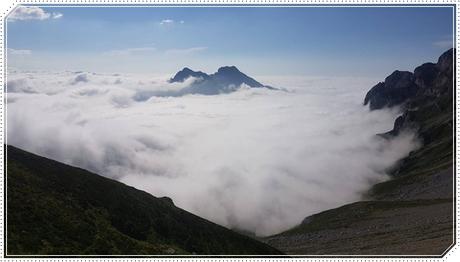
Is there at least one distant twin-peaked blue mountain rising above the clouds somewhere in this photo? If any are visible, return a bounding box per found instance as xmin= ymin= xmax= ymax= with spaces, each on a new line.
xmin=169 ymin=66 xmax=266 ymax=95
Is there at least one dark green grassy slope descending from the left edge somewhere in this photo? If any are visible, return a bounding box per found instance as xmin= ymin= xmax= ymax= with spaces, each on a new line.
xmin=7 ymin=146 xmax=280 ymax=255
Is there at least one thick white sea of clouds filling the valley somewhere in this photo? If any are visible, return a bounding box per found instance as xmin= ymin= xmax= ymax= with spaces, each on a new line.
xmin=7 ymin=70 xmax=418 ymax=236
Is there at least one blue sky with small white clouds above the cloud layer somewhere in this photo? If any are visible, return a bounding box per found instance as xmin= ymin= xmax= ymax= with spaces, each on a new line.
xmin=7 ymin=6 xmax=453 ymax=77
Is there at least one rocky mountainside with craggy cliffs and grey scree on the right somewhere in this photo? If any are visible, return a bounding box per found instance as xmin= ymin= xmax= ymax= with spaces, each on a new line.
xmin=266 ymin=50 xmax=455 ymax=255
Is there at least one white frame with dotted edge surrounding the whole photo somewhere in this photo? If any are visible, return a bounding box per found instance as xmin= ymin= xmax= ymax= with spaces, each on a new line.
xmin=0 ymin=0 xmax=460 ymax=262
